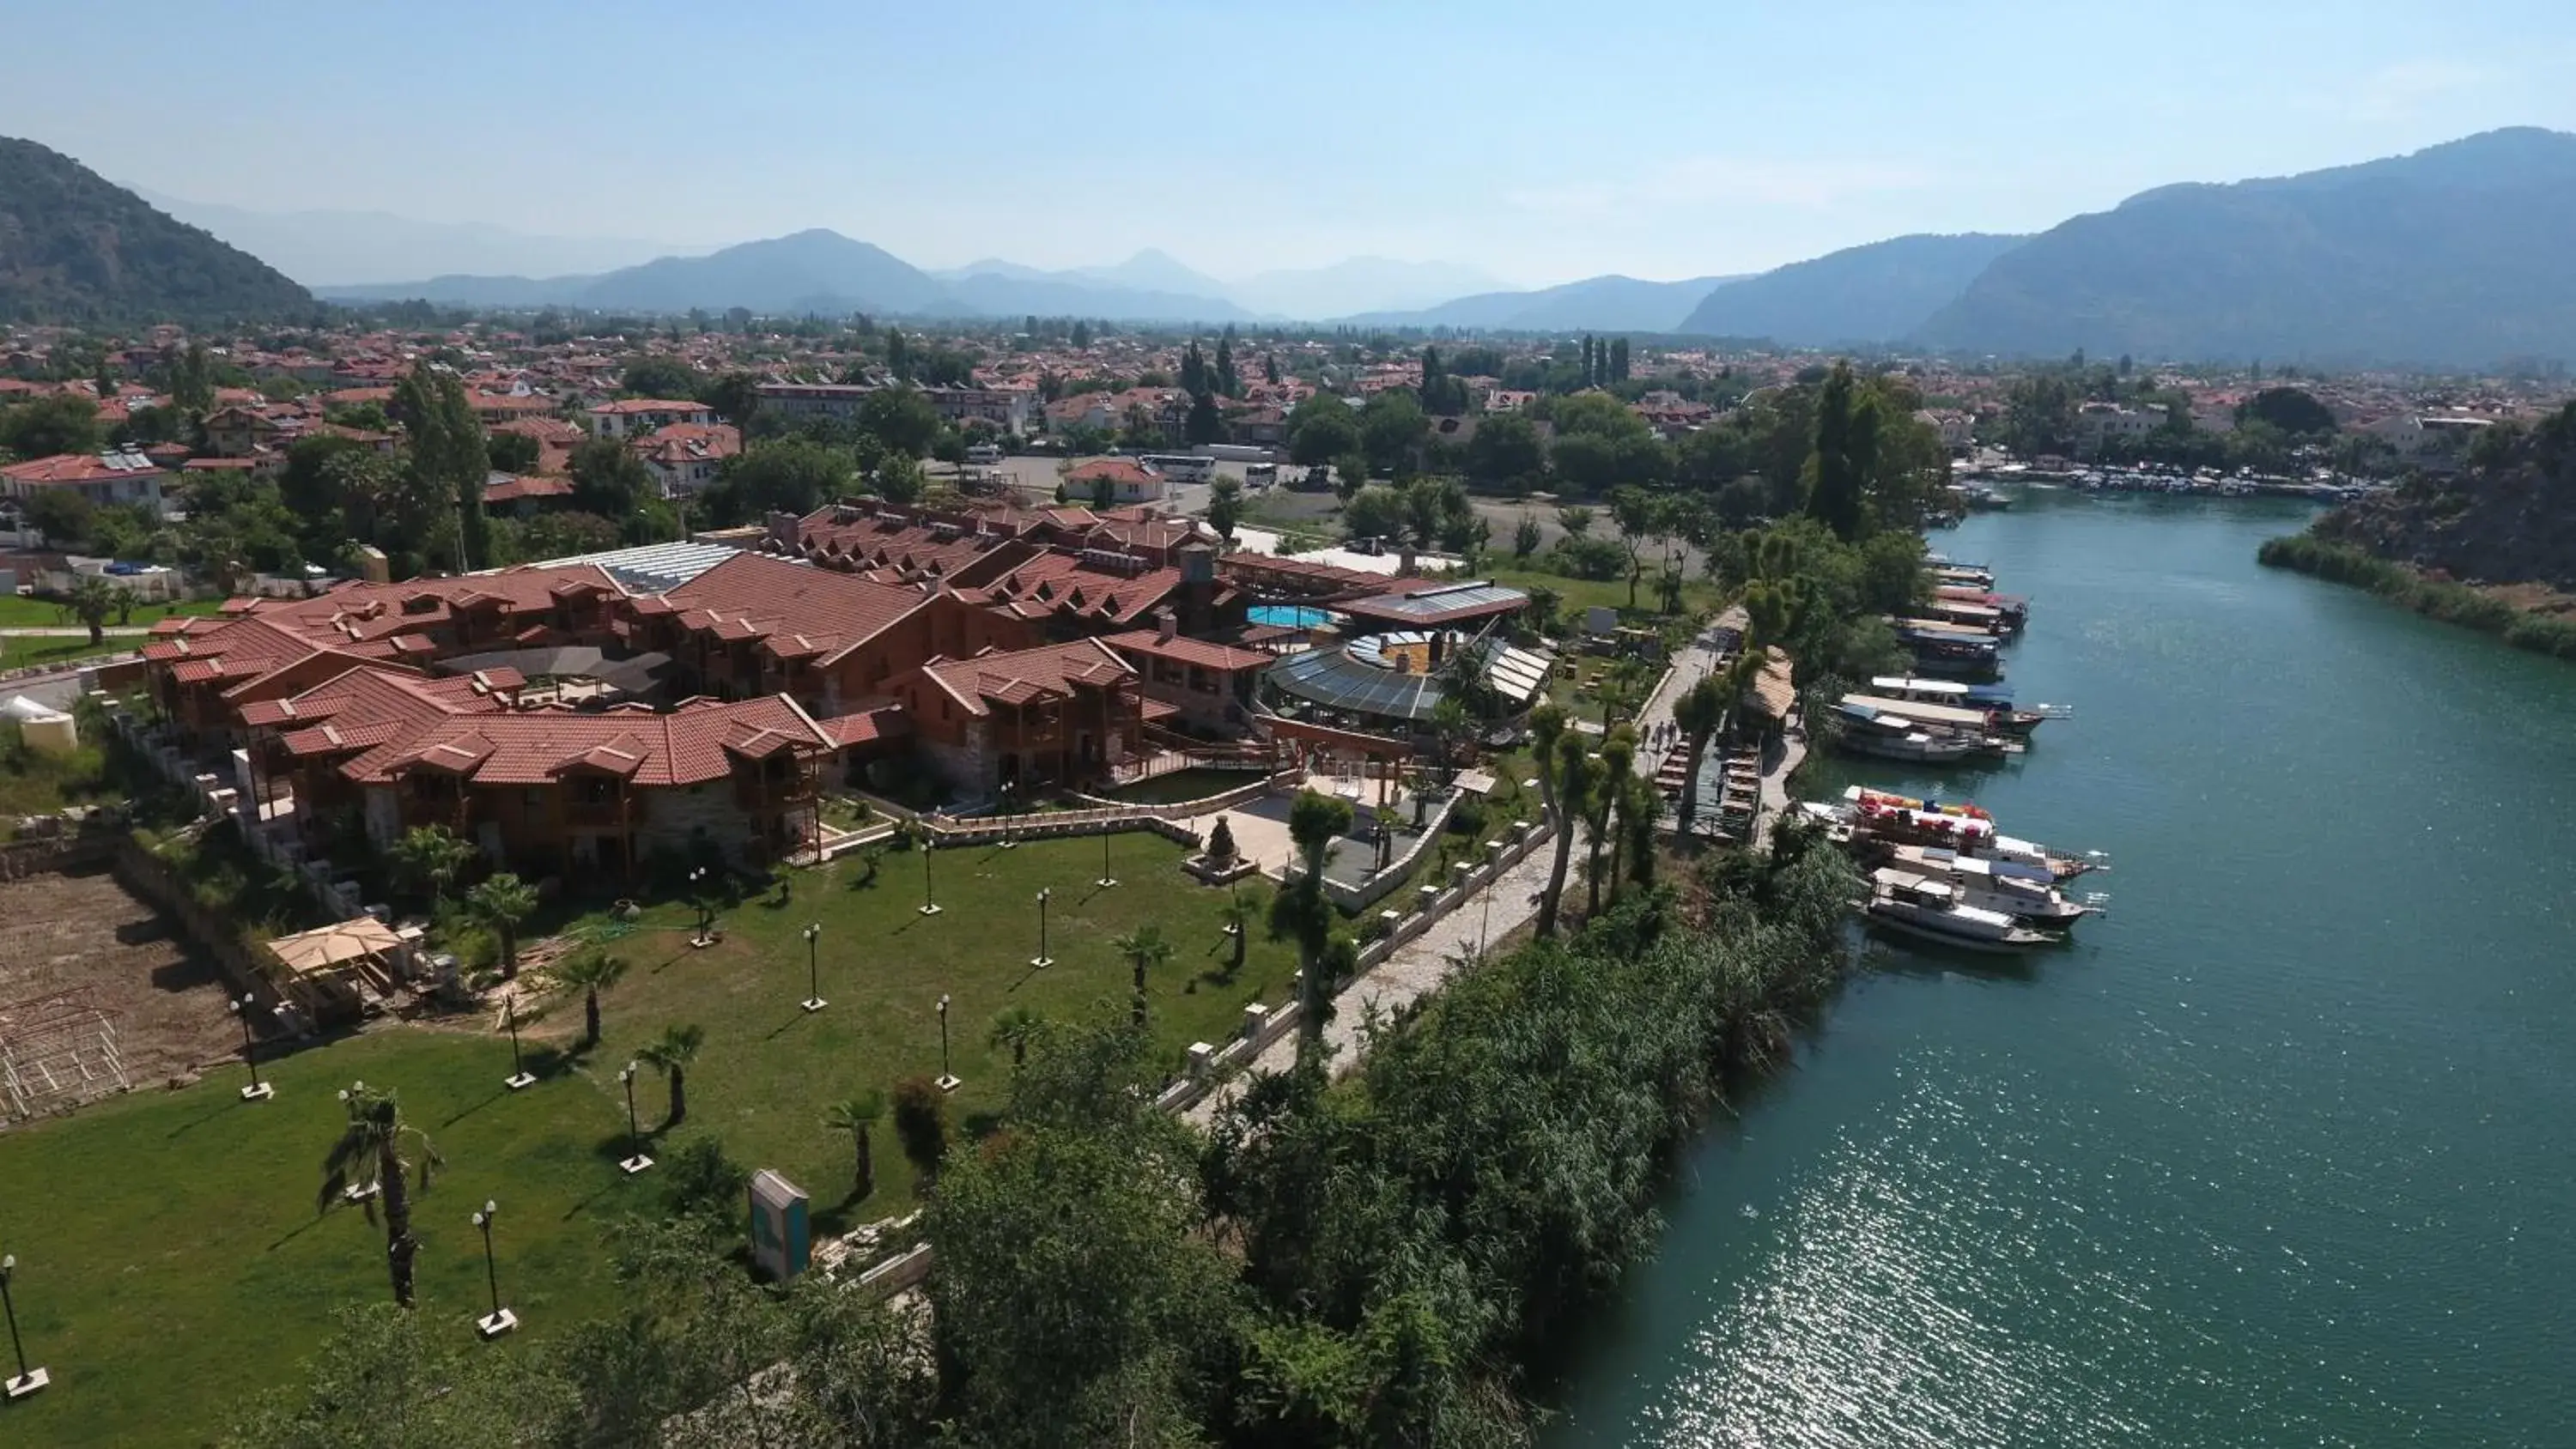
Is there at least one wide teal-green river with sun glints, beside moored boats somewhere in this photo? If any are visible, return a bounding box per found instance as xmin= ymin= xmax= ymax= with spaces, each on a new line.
xmin=1546 ymin=492 xmax=2576 ymax=1449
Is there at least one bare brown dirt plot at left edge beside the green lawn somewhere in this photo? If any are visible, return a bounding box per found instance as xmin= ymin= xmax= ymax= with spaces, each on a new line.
xmin=0 ymin=870 xmax=242 ymax=1101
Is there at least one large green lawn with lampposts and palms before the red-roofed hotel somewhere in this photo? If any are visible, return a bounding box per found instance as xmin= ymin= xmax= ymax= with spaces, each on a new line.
xmin=0 ymin=834 xmax=1296 ymax=1444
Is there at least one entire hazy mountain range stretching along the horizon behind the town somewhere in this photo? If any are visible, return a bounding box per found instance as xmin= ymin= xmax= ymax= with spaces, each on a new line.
xmin=0 ymin=129 xmax=2576 ymax=368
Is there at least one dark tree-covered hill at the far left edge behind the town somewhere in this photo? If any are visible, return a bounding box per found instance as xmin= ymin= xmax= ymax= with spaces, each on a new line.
xmin=0 ymin=136 xmax=314 ymax=324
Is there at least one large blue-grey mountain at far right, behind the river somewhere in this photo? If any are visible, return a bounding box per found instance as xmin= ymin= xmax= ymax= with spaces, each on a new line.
xmin=1919 ymin=129 xmax=2576 ymax=368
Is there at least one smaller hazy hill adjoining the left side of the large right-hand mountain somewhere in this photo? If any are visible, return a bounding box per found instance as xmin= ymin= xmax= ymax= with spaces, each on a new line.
xmin=1674 ymin=232 xmax=2022 ymax=348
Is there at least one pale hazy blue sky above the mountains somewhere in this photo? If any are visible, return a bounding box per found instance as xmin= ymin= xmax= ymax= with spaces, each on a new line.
xmin=0 ymin=0 xmax=2576 ymax=283
